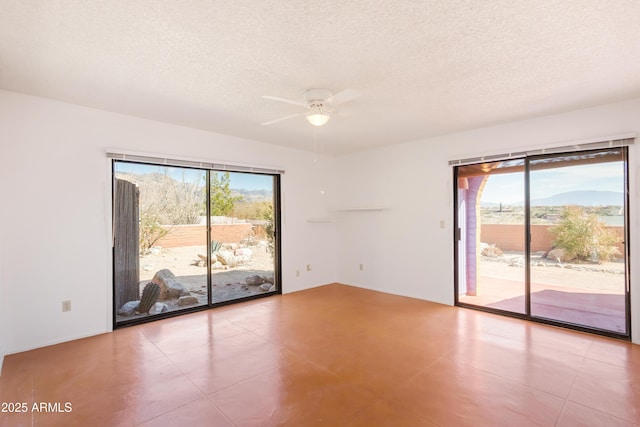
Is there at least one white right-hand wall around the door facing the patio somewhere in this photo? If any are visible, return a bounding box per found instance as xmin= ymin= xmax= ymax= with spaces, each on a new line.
xmin=336 ymin=99 xmax=640 ymax=343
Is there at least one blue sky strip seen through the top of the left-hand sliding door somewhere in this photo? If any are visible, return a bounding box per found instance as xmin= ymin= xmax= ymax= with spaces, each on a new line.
xmin=116 ymin=162 xmax=273 ymax=191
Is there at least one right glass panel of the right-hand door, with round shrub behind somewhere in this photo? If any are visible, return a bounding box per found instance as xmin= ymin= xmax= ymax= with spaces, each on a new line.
xmin=529 ymin=150 xmax=627 ymax=334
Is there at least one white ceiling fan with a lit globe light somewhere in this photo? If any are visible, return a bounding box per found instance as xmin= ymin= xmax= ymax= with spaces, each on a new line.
xmin=261 ymin=89 xmax=361 ymax=126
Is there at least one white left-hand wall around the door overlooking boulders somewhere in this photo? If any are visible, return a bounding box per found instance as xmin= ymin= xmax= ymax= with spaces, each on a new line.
xmin=0 ymin=91 xmax=336 ymax=354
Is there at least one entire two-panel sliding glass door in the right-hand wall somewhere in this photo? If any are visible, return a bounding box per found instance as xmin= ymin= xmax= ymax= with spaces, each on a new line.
xmin=455 ymin=148 xmax=629 ymax=337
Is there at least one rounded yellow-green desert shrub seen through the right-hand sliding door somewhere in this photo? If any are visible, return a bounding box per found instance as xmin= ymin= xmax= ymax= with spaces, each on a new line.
xmin=550 ymin=206 xmax=620 ymax=262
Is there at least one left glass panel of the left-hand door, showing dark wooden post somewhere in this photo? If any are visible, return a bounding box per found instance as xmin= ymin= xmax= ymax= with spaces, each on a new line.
xmin=113 ymin=162 xmax=209 ymax=323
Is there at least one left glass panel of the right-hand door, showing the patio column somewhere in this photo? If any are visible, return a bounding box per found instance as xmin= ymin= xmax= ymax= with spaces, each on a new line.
xmin=457 ymin=160 xmax=526 ymax=314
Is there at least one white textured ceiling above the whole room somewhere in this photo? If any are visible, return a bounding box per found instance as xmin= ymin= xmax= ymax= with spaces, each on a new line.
xmin=0 ymin=0 xmax=640 ymax=155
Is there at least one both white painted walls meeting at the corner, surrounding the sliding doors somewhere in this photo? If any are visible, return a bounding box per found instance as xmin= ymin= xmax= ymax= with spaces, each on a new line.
xmin=5 ymin=91 xmax=640 ymax=355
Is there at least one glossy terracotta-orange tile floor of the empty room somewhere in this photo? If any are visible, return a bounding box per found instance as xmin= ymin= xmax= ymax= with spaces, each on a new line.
xmin=0 ymin=284 xmax=640 ymax=427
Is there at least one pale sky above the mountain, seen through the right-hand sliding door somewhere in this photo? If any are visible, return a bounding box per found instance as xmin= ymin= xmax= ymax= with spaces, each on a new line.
xmin=482 ymin=162 xmax=624 ymax=203
